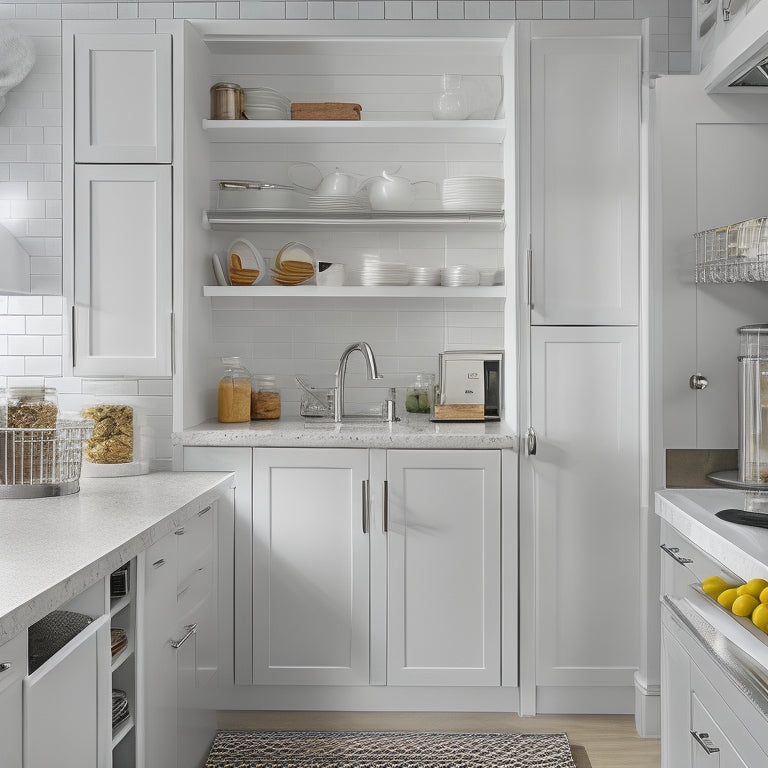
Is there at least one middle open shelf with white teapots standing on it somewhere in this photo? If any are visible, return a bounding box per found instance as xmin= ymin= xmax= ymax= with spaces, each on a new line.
xmin=203 ymin=209 xmax=504 ymax=232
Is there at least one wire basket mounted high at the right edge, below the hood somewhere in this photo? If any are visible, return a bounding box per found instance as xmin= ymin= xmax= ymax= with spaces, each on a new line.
xmin=694 ymin=216 xmax=768 ymax=283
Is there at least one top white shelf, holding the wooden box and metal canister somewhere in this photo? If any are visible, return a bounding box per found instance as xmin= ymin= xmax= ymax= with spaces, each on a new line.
xmin=203 ymin=120 xmax=506 ymax=144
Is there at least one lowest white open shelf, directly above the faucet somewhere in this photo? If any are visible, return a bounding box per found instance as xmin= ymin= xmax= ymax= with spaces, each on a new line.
xmin=203 ymin=285 xmax=507 ymax=299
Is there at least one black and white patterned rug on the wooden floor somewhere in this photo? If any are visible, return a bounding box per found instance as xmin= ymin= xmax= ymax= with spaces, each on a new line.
xmin=205 ymin=730 xmax=588 ymax=768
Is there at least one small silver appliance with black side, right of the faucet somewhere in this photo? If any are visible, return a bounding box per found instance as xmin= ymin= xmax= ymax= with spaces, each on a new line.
xmin=433 ymin=350 xmax=504 ymax=421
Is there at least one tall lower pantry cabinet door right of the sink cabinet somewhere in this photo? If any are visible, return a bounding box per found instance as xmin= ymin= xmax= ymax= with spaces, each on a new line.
xmin=520 ymin=326 xmax=640 ymax=711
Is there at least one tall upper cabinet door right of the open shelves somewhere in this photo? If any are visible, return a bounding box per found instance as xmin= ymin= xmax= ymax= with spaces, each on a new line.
xmin=531 ymin=37 xmax=640 ymax=325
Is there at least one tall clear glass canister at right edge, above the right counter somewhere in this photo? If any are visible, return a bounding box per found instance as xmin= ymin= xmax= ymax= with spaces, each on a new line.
xmin=738 ymin=324 xmax=768 ymax=486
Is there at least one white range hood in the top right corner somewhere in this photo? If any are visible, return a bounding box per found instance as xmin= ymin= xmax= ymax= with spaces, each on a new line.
xmin=703 ymin=2 xmax=768 ymax=94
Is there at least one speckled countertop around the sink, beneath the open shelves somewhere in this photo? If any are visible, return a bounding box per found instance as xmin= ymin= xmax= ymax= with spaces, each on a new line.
xmin=173 ymin=418 xmax=517 ymax=449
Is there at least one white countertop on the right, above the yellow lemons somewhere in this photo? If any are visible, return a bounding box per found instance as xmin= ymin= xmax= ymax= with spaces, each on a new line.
xmin=656 ymin=488 xmax=768 ymax=580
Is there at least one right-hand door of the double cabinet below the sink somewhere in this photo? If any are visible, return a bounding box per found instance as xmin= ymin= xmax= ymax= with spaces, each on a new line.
xmin=385 ymin=450 xmax=501 ymax=685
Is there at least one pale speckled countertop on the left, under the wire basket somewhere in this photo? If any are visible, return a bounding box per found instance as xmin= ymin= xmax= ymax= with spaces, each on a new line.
xmin=0 ymin=472 xmax=233 ymax=644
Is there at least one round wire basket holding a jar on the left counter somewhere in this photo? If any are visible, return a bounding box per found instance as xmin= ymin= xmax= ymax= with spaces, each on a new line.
xmin=0 ymin=418 xmax=93 ymax=499
